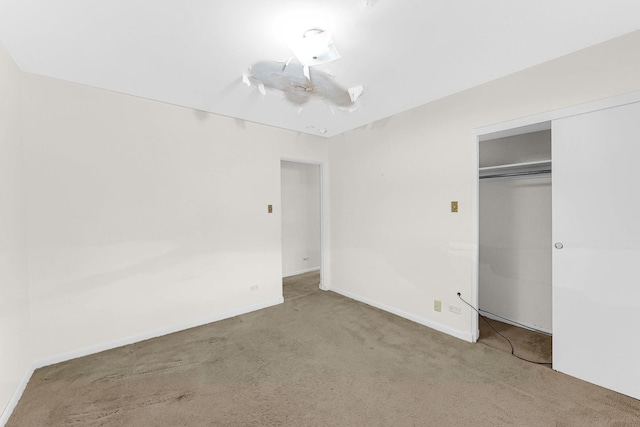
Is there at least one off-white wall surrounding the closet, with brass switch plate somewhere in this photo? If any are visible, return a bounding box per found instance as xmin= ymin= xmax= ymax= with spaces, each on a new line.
xmin=329 ymin=32 xmax=640 ymax=340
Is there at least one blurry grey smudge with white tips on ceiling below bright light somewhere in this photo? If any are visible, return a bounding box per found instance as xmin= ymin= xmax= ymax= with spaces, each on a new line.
xmin=242 ymin=60 xmax=364 ymax=111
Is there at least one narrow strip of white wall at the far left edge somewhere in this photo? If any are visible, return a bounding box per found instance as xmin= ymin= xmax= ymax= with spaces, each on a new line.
xmin=0 ymin=43 xmax=31 ymax=418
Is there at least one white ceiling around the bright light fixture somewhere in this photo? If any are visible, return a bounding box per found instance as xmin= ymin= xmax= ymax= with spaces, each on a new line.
xmin=0 ymin=0 xmax=640 ymax=137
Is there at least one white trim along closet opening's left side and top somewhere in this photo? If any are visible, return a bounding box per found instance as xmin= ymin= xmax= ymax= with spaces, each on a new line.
xmin=463 ymin=91 xmax=640 ymax=342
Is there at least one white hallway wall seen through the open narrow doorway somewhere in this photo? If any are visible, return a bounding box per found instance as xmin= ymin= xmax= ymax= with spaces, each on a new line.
xmin=281 ymin=161 xmax=320 ymax=277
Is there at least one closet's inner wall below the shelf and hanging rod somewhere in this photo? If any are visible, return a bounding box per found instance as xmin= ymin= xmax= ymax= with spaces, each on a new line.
xmin=478 ymin=176 xmax=552 ymax=332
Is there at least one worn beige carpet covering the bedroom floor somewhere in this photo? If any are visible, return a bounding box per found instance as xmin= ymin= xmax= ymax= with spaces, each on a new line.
xmin=8 ymin=274 xmax=640 ymax=427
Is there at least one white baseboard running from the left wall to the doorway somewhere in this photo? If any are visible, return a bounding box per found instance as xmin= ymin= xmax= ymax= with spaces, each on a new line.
xmin=0 ymin=297 xmax=284 ymax=426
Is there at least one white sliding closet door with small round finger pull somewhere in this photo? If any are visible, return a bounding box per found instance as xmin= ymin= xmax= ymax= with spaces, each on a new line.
xmin=552 ymin=103 xmax=640 ymax=399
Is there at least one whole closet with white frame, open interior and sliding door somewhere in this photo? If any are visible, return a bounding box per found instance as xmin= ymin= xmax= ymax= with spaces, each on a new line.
xmin=472 ymin=97 xmax=640 ymax=399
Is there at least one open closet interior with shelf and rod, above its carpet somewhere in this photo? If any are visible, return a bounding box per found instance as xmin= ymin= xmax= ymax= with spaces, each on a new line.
xmin=478 ymin=129 xmax=553 ymax=333
